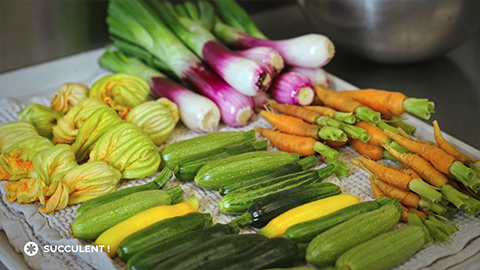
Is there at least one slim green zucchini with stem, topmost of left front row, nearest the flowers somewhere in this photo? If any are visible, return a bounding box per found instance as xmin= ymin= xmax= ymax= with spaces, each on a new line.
xmin=76 ymin=168 xmax=173 ymax=217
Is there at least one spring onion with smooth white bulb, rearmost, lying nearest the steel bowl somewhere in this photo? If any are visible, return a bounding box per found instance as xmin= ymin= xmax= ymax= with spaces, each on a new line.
xmin=212 ymin=0 xmax=335 ymax=68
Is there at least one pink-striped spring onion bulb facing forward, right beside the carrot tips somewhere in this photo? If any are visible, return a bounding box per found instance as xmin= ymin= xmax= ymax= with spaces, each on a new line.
xmin=268 ymin=72 xmax=315 ymax=106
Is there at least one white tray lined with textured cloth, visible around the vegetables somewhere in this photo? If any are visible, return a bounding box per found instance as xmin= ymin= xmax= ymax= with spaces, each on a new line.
xmin=0 ymin=49 xmax=480 ymax=269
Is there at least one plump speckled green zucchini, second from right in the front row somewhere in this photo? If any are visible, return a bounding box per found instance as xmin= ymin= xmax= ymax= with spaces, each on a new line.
xmin=305 ymin=202 xmax=402 ymax=267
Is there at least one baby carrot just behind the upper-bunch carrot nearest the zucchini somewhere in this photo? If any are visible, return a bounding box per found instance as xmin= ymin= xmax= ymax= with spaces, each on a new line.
xmin=260 ymin=110 xmax=347 ymax=141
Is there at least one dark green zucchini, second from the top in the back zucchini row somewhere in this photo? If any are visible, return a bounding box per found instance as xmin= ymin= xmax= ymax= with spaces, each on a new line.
xmin=175 ymin=140 xmax=268 ymax=181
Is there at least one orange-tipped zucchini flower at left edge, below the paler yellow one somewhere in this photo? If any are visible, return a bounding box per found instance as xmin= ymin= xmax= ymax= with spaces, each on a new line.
xmin=0 ymin=135 xmax=53 ymax=180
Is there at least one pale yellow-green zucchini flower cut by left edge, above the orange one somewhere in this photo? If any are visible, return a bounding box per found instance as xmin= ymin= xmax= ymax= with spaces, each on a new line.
xmin=0 ymin=122 xmax=38 ymax=153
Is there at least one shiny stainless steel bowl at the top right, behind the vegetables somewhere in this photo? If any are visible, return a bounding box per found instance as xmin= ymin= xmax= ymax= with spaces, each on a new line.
xmin=298 ymin=0 xmax=480 ymax=64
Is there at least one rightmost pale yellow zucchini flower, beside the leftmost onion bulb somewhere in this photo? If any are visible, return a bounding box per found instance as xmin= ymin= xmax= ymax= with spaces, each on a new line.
xmin=125 ymin=101 xmax=175 ymax=146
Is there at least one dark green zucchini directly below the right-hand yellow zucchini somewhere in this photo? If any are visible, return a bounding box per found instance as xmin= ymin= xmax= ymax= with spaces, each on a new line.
xmin=283 ymin=198 xmax=381 ymax=243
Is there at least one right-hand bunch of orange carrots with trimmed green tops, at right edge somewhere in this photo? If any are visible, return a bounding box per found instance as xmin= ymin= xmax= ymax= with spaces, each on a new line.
xmin=352 ymin=121 xmax=480 ymax=241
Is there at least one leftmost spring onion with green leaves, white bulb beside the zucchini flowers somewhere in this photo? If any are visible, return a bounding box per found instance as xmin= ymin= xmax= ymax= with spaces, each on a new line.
xmin=98 ymin=48 xmax=220 ymax=132
